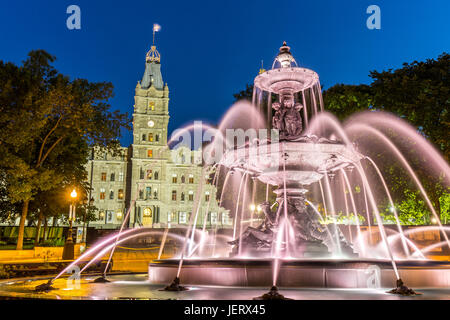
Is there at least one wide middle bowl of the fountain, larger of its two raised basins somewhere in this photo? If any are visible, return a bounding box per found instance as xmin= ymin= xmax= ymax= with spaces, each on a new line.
xmin=220 ymin=136 xmax=363 ymax=188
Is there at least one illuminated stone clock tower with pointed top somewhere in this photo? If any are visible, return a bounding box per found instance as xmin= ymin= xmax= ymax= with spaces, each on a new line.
xmin=129 ymin=45 xmax=169 ymax=227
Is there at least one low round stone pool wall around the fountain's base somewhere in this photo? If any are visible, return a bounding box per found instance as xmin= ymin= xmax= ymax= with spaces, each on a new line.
xmin=148 ymin=259 xmax=450 ymax=289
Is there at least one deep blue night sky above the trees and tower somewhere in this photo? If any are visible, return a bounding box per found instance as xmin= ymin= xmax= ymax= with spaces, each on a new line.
xmin=0 ymin=0 xmax=450 ymax=146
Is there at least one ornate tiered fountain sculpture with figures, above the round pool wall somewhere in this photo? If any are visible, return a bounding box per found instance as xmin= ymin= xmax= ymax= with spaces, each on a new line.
xmin=220 ymin=43 xmax=362 ymax=257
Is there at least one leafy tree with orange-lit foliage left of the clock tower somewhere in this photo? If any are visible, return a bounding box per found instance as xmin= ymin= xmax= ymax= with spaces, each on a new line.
xmin=0 ymin=50 xmax=130 ymax=250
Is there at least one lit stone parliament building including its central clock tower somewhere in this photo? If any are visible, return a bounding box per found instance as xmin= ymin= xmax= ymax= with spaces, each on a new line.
xmin=86 ymin=45 xmax=232 ymax=229
